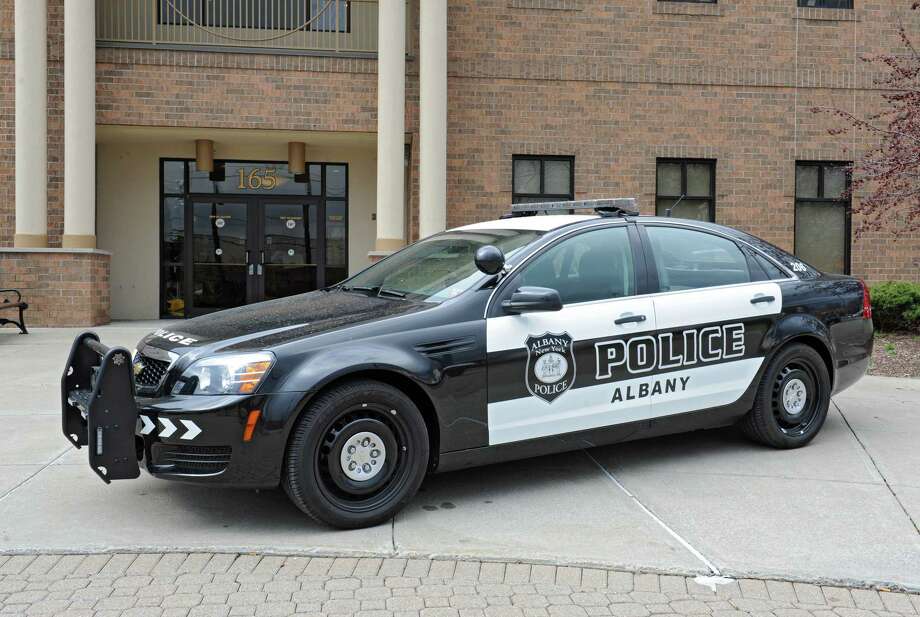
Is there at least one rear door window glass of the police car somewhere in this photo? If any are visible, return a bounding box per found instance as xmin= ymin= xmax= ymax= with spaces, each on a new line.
xmin=646 ymin=226 xmax=751 ymax=291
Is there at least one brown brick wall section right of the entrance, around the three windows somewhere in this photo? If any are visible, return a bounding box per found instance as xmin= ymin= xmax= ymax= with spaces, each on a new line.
xmin=409 ymin=0 xmax=920 ymax=280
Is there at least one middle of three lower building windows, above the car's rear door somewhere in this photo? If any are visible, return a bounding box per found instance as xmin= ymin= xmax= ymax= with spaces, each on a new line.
xmin=655 ymin=159 xmax=716 ymax=222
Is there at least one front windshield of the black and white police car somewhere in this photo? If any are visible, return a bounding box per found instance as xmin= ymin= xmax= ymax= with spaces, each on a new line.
xmin=341 ymin=229 xmax=540 ymax=302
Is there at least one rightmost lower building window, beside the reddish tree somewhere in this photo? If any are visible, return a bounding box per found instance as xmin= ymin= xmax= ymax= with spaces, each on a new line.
xmin=795 ymin=161 xmax=850 ymax=274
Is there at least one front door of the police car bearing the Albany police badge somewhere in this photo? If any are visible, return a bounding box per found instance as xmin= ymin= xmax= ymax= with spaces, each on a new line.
xmin=486 ymin=222 xmax=655 ymax=445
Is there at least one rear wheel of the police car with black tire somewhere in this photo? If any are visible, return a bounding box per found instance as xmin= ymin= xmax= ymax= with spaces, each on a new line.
xmin=741 ymin=343 xmax=831 ymax=449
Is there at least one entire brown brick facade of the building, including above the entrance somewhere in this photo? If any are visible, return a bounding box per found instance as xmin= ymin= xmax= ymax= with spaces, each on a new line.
xmin=0 ymin=0 xmax=920 ymax=298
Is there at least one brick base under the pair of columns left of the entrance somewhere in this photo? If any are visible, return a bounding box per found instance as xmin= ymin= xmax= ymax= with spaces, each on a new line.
xmin=0 ymin=248 xmax=112 ymax=327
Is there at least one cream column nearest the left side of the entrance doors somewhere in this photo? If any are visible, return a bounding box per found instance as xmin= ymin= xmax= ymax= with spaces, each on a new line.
xmin=62 ymin=0 xmax=96 ymax=248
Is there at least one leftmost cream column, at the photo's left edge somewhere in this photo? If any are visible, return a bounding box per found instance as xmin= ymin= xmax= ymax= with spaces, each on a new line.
xmin=13 ymin=0 xmax=48 ymax=248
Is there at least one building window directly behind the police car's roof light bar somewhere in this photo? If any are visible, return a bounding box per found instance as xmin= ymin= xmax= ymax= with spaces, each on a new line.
xmin=511 ymin=154 xmax=575 ymax=204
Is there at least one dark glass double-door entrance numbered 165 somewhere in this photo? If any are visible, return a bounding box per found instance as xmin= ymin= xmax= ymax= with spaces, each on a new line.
xmin=161 ymin=161 xmax=348 ymax=317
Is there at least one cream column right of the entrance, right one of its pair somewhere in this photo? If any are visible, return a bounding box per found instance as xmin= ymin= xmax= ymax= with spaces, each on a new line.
xmin=419 ymin=0 xmax=447 ymax=238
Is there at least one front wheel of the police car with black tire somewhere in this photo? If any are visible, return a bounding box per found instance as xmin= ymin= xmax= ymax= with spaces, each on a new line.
xmin=282 ymin=380 xmax=428 ymax=529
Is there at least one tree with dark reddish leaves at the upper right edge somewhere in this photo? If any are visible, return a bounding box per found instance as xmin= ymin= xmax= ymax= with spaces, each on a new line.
xmin=812 ymin=0 xmax=920 ymax=235
